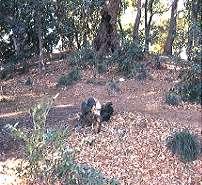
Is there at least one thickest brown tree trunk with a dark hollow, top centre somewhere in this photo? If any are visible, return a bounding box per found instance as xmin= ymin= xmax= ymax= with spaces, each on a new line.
xmin=94 ymin=0 xmax=121 ymax=56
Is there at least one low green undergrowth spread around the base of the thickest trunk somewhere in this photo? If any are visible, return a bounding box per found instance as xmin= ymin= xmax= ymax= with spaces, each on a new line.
xmin=69 ymin=42 xmax=143 ymax=78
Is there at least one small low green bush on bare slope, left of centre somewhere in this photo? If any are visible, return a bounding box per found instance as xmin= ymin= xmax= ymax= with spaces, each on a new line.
xmin=58 ymin=68 xmax=81 ymax=86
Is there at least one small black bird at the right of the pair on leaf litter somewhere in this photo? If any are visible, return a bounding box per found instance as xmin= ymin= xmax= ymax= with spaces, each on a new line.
xmin=100 ymin=102 xmax=114 ymax=122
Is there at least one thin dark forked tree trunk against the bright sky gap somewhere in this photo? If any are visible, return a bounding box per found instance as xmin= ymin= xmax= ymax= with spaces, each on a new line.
xmin=144 ymin=0 xmax=154 ymax=52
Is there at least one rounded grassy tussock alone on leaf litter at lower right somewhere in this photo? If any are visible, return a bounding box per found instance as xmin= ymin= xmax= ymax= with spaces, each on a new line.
xmin=166 ymin=131 xmax=200 ymax=162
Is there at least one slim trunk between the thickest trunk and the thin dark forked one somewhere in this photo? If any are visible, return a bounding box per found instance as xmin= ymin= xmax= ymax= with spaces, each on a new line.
xmin=133 ymin=0 xmax=141 ymax=43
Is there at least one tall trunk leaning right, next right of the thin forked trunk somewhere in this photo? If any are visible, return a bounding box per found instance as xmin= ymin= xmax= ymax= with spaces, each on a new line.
xmin=163 ymin=0 xmax=179 ymax=55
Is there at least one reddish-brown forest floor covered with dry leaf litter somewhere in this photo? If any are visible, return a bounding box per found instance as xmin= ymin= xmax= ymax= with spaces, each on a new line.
xmin=0 ymin=59 xmax=202 ymax=185
